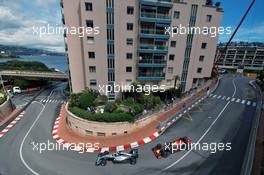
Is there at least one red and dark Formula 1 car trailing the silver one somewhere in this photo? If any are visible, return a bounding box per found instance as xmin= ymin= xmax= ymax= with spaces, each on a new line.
xmin=152 ymin=137 xmax=191 ymax=159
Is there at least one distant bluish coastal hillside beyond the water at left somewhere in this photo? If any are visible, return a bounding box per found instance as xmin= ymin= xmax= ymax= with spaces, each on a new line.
xmin=0 ymin=44 xmax=65 ymax=56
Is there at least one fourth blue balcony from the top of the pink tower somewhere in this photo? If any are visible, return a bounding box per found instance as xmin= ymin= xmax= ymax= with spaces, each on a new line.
xmin=139 ymin=44 xmax=168 ymax=54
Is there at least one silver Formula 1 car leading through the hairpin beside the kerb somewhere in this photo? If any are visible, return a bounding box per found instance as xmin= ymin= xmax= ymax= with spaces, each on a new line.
xmin=95 ymin=149 xmax=138 ymax=166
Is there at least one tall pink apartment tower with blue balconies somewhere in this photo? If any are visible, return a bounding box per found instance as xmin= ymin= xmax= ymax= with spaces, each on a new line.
xmin=61 ymin=0 xmax=223 ymax=99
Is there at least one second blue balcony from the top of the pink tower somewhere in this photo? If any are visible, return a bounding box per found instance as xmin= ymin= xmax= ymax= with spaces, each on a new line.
xmin=140 ymin=12 xmax=171 ymax=24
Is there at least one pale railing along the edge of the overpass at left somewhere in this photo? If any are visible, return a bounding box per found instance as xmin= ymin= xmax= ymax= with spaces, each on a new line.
xmin=0 ymin=70 xmax=68 ymax=79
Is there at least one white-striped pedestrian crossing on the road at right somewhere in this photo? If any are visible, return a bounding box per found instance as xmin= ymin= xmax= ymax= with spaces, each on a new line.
xmin=209 ymin=94 xmax=257 ymax=107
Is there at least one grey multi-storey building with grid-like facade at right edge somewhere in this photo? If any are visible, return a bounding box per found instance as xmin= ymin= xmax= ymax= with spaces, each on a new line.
xmin=217 ymin=46 xmax=264 ymax=71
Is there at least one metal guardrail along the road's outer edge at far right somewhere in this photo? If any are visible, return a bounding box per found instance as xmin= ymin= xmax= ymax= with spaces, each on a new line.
xmin=240 ymin=80 xmax=263 ymax=175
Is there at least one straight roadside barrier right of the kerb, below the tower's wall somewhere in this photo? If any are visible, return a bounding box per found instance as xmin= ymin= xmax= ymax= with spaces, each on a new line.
xmin=158 ymin=78 xmax=222 ymax=132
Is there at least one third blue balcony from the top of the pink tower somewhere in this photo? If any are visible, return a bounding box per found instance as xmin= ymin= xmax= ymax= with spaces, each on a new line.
xmin=139 ymin=29 xmax=170 ymax=40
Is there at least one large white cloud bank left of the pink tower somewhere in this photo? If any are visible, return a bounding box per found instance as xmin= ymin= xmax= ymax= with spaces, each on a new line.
xmin=0 ymin=3 xmax=64 ymax=52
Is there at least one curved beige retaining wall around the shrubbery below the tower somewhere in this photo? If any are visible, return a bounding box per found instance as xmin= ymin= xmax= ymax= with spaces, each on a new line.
xmin=65 ymin=78 xmax=215 ymax=136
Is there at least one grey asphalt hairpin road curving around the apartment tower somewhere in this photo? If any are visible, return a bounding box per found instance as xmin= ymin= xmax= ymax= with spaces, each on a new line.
xmin=0 ymin=76 xmax=257 ymax=175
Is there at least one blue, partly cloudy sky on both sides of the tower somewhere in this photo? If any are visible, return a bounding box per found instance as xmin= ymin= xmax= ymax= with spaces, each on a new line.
xmin=0 ymin=0 xmax=264 ymax=52
